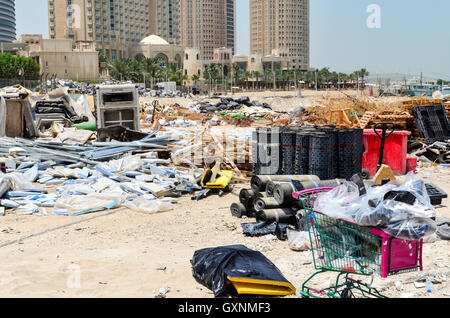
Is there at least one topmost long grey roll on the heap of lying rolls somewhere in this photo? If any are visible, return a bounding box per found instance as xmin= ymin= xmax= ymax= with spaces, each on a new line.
xmin=273 ymin=179 xmax=345 ymax=205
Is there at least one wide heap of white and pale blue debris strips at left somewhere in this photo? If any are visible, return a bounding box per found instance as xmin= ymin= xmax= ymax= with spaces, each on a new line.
xmin=0 ymin=131 xmax=203 ymax=216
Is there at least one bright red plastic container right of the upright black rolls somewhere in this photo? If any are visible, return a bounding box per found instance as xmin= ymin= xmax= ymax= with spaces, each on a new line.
xmin=363 ymin=129 xmax=411 ymax=177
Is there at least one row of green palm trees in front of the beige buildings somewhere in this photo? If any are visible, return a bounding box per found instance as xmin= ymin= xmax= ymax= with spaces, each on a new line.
xmin=101 ymin=55 xmax=370 ymax=90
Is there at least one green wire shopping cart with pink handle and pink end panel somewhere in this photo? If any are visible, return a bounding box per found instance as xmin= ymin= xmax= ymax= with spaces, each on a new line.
xmin=293 ymin=188 xmax=423 ymax=298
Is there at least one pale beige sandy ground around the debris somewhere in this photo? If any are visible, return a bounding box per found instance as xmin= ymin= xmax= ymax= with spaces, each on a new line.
xmin=0 ymin=91 xmax=450 ymax=298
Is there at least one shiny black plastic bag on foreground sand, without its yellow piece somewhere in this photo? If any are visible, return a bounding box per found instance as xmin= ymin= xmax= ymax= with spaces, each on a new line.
xmin=191 ymin=245 xmax=290 ymax=297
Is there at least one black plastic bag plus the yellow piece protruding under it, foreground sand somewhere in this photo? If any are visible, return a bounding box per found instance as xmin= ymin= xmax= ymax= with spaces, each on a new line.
xmin=191 ymin=245 xmax=295 ymax=297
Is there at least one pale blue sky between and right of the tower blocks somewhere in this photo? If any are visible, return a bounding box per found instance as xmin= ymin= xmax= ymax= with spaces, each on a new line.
xmin=16 ymin=0 xmax=450 ymax=80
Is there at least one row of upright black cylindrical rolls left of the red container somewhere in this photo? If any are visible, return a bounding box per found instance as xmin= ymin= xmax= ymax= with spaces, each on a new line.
xmin=252 ymin=125 xmax=364 ymax=180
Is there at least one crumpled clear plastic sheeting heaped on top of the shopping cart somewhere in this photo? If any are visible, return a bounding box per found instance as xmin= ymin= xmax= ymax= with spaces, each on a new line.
xmin=314 ymin=175 xmax=437 ymax=240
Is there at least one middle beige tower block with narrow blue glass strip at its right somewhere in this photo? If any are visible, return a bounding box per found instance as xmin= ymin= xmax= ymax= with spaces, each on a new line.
xmin=180 ymin=0 xmax=236 ymax=61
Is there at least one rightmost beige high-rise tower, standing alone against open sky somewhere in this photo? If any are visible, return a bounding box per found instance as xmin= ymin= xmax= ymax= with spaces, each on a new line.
xmin=250 ymin=0 xmax=310 ymax=69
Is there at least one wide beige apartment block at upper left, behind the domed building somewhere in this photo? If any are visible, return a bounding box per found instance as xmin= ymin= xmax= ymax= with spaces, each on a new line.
xmin=48 ymin=0 xmax=180 ymax=60
